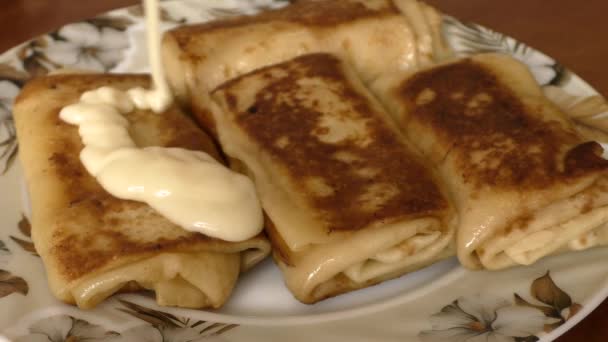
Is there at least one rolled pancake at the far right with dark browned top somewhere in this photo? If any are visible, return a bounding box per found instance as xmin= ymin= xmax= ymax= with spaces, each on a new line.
xmin=374 ymin=54 xmax=608 ymax=269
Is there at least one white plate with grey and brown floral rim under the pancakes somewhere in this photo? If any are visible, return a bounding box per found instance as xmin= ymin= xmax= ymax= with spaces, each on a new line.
xmin=0 ymin=0 xmax=608 ymax=342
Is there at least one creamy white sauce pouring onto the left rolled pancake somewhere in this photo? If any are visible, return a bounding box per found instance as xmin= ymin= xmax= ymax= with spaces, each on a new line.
xmin=59 ymin=0 xmax=263 ymax=241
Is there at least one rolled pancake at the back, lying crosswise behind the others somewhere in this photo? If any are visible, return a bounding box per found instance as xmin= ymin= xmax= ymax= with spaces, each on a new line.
xmin=163 ymin=0 xmax=445 ymax=134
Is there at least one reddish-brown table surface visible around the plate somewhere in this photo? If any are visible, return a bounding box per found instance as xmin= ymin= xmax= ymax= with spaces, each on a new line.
xmin=0 ymin=0 xmax=608 ymax=342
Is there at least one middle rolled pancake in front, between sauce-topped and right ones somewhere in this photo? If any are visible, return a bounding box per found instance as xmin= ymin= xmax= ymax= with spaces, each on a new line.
xmin=212 ymin=54 xmax=455 ymax=303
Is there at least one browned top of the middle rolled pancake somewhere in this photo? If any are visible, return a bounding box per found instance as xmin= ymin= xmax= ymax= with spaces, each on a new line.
xmin=218 ymin=54 xmax=447 ymax=231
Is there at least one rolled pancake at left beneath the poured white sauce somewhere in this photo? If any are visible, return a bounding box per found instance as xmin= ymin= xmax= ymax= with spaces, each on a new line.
xmin=14 ymin=74 xmax=270 ymax=308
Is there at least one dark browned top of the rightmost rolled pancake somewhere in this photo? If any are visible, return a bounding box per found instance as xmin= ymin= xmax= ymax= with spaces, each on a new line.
xmin=398 ymin=60 xmax=608 ymax=188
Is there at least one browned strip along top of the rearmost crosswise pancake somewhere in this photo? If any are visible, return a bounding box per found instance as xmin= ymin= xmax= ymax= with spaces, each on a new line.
xmin=169 ymin=0 xmax=399 ymax=49
